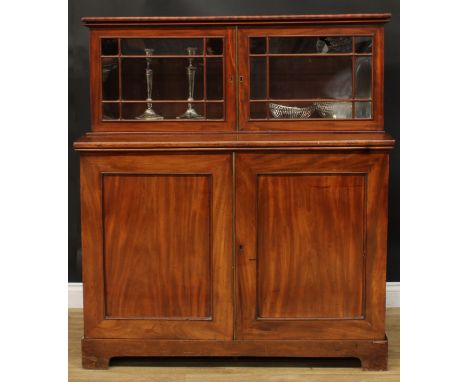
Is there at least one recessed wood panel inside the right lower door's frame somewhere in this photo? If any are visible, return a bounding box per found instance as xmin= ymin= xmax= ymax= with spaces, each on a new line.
xmin=257 ymin=173 xmax=366 ymax=319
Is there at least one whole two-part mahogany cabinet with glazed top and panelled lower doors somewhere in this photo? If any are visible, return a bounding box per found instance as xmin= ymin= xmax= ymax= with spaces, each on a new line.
xmin=74 ymin=14 xmax=394 ymax=370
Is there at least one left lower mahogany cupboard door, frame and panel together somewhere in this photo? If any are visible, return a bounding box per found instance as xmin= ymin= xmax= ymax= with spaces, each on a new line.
xmin=81 ymin=153 xmax=233 ymax=340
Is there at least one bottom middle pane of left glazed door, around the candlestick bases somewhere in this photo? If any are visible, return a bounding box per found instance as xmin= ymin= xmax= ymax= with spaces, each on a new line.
xmin=122 ymin=102 xmax=203 ymax=121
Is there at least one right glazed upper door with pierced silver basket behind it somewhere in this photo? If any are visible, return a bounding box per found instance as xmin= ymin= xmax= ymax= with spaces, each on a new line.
xmin=238 ymin=26 xmax=383 ymax=131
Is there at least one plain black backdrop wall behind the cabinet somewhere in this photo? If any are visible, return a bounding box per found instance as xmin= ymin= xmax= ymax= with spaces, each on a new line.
xmin=68 ymin=0 xmax=400 ymax=282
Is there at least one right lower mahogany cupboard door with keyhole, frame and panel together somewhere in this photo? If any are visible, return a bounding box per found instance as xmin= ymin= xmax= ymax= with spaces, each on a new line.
xmin=235 ymin=152 xmax=388 ymax=340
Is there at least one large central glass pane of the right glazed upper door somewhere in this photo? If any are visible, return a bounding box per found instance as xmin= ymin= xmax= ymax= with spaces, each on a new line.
xmin=268 ymin=56 xmax=352 ymax=99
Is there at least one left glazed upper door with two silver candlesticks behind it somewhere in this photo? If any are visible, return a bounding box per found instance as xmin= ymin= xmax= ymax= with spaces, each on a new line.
xmin=90 ymin=27 xmax=236 ymax=132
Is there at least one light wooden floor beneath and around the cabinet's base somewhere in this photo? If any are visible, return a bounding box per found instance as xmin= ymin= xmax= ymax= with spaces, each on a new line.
xmin=68 ymin=308 xmax=400 ymax=382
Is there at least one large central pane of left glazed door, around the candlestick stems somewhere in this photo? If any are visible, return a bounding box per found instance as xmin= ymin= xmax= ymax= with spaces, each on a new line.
xmin=122 ymin=58 xmax=203 ymax=101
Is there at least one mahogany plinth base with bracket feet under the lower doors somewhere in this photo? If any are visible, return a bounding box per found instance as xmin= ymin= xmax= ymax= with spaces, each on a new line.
xmin=81 ymin=338 xmax=388 ymax=370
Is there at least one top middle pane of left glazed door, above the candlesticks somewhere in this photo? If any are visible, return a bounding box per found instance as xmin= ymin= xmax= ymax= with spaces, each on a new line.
xmin=121 ymin=38 xmax=203 ymax=56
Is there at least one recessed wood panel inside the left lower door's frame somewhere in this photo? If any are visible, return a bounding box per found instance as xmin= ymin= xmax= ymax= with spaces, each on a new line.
xmin=103 ymin=174 xmax=212 ymax=319
